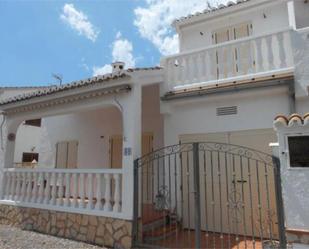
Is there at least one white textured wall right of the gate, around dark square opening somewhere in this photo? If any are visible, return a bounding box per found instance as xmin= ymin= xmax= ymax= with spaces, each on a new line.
xmin=273 ymin=116 xmax=309 ymax=248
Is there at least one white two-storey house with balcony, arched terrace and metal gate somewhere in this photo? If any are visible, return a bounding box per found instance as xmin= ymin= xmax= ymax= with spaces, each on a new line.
xmin=0 ymin=0 xmax=309 ymax=248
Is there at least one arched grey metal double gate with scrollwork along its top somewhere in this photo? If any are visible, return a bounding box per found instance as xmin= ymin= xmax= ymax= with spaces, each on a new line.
xmin=133 ymin=142 xmax=286 ymax=248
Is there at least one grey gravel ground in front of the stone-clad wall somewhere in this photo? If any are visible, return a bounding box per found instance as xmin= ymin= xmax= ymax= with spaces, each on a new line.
xmin=0 ymin=225 xmax=103 ymax=249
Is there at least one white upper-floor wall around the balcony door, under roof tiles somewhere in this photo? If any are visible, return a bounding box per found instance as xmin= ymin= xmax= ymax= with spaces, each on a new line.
xmin=180 ymin=3 xmax=289 ymax=52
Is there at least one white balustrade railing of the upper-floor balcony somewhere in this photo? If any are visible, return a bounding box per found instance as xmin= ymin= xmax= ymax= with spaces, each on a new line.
xmin=162 ymin=29 xmax=294 ymax=91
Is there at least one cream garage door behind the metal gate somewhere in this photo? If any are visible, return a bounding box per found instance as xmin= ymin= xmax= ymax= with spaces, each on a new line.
xmin=180 ymin=129 xmax=278 ymax=237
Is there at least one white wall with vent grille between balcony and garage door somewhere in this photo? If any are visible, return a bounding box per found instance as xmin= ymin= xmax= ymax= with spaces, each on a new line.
xmin=162 ymin=87 xmax=289 ymax=145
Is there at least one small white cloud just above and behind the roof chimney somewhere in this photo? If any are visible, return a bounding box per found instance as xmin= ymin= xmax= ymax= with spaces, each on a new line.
xmin=92 ymin=32 xmax=136 ymax=76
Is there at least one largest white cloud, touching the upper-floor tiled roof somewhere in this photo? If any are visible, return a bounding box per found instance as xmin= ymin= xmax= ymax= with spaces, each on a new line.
xmin=134 ymin=0 xmax=227 ymax=55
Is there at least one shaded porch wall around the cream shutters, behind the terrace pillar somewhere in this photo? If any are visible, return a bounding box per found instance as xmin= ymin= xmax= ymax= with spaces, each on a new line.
xmin=35 ymin=85 xmax=163 ymax=168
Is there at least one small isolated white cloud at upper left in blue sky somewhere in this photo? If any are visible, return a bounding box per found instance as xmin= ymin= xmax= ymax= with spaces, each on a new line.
xmin=60 ymin=3 xmax=99 ymax=42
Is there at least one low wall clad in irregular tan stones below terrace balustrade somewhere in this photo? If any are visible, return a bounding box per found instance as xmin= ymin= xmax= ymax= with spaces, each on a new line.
xmin=0 ymin=204 xmax=132 ymax=248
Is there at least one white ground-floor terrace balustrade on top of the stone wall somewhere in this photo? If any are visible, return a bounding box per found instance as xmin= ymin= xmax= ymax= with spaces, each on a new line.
xmin=0 ymin=168 xmax=122 ymax=218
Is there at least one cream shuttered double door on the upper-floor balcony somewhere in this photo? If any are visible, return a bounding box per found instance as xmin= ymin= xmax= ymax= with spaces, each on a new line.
xmin=212 ymin=23 xmax=254 ymax=79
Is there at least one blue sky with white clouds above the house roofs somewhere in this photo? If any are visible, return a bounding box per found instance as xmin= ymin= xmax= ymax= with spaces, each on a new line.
xmin=0 ymin=0 xmax=223 ymax=86
